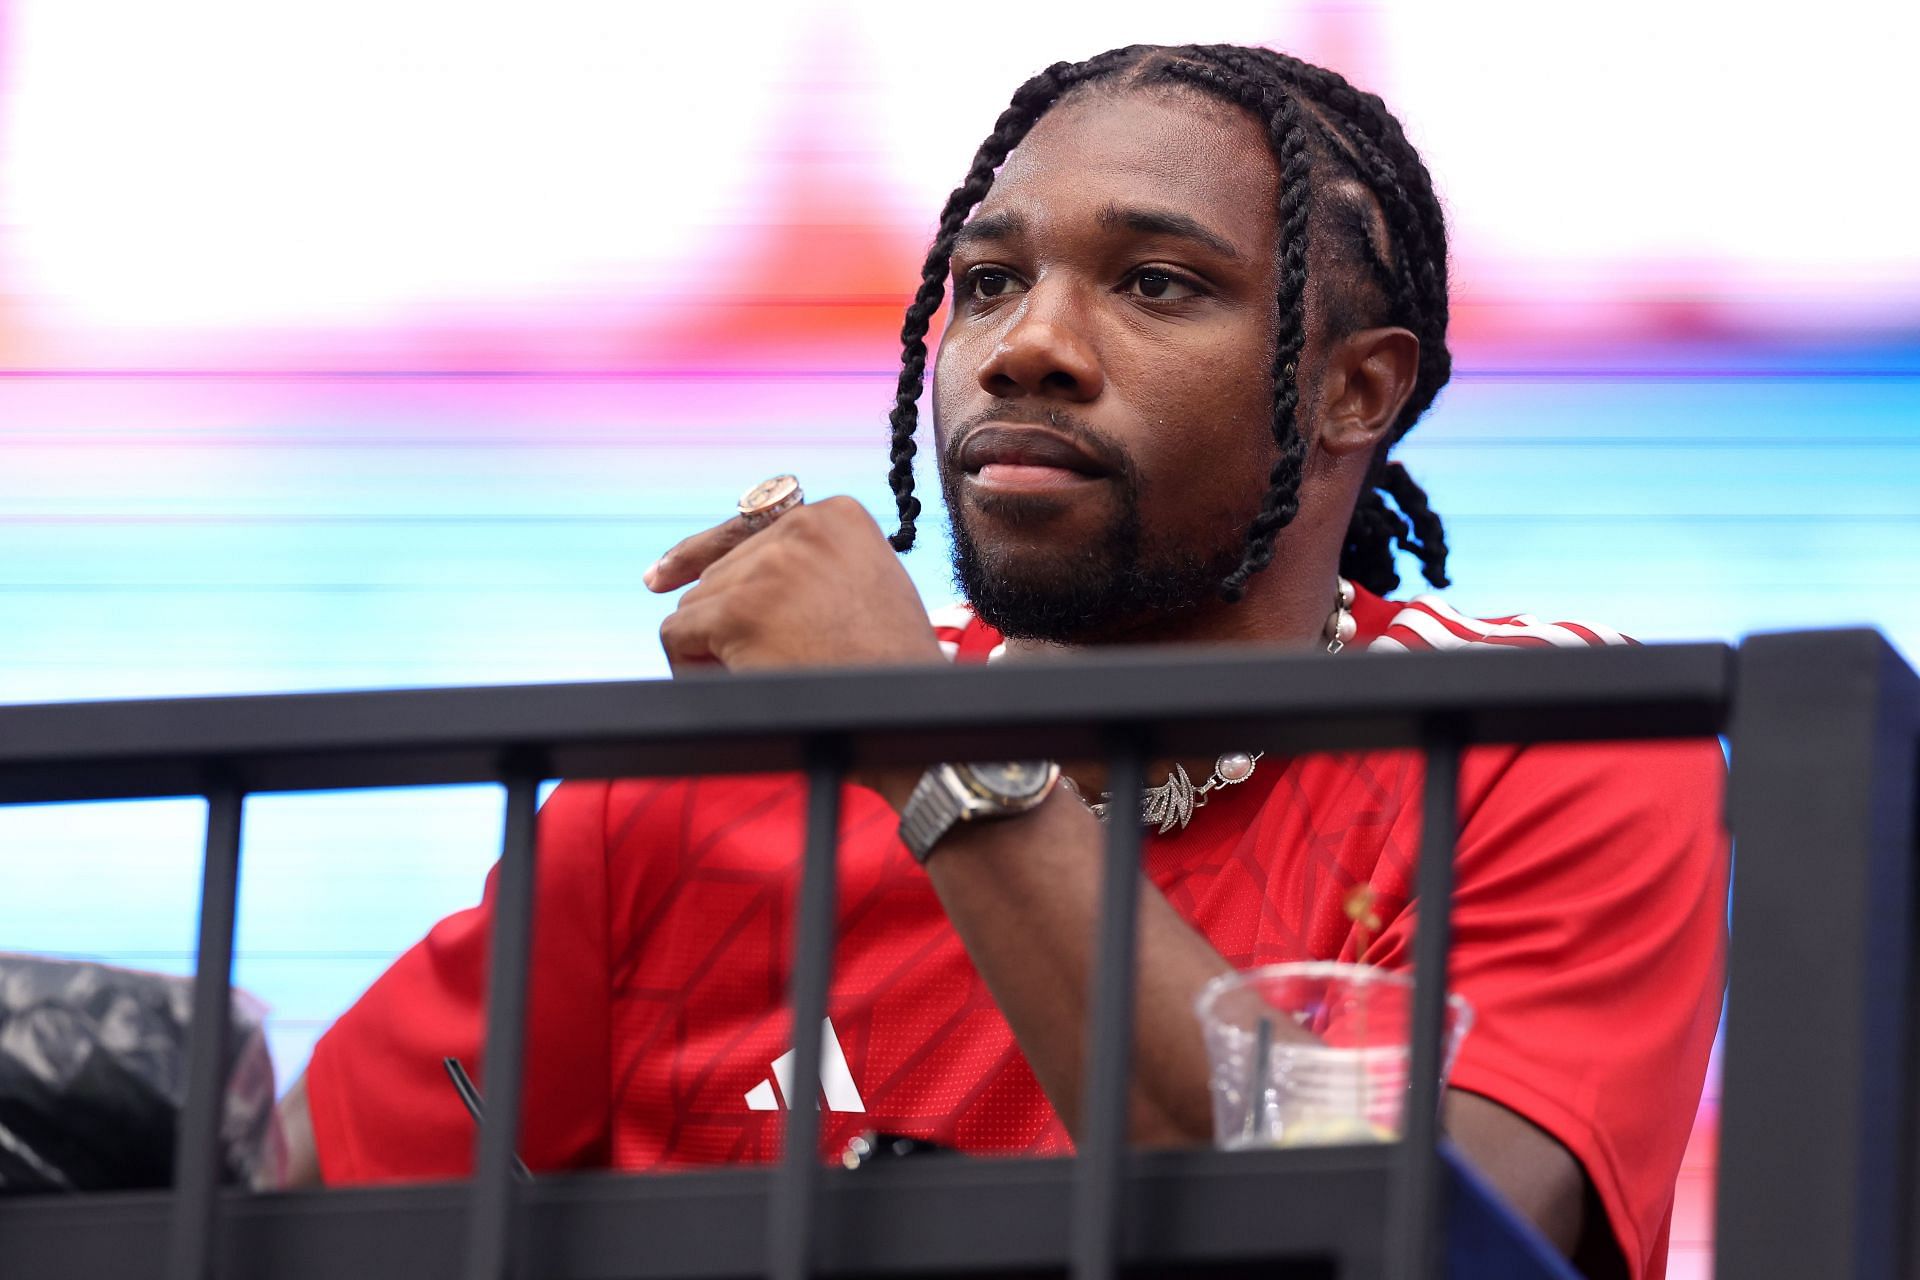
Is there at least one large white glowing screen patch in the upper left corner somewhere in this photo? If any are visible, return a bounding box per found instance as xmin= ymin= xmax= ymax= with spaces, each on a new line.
xmin=4 ymin=0 xmax=802 ymax=326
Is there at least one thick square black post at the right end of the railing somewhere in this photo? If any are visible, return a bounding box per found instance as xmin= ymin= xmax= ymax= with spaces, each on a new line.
xmin=1715 ymin=631 xmax=1920 ymax=1280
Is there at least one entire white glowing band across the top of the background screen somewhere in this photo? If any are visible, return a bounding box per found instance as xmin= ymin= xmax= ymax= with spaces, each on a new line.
xmin=0 ymin=0 xmax=1920 ymax=332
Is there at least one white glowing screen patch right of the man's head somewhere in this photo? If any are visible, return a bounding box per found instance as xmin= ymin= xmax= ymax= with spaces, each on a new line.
xmin=1379 ymin=0 xmax=1920 ymax=324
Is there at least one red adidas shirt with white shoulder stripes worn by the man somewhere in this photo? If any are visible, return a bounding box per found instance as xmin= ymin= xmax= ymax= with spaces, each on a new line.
xmin=307 ymin=591 xmax=1726 ymax=1276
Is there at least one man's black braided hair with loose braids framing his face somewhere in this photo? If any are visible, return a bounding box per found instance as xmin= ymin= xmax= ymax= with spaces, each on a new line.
xmin=887 ymin=44 xmax=1453 ymax=601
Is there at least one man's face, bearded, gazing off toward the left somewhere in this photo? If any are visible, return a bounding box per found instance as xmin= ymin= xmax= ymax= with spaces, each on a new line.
xmin=933 ymin=92 xmax=1277 ymax=641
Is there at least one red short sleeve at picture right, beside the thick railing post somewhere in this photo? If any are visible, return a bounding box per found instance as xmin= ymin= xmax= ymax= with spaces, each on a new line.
xmin=1379 ymin=741 xmax=1728 ymax=1278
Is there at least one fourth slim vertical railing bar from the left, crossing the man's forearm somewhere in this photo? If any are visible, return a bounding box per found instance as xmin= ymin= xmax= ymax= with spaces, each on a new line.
xmin=1071 ymin=733 xmax=1146 ymax=1280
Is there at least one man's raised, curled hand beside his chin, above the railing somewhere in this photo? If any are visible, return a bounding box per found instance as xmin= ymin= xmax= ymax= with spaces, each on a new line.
xmin=645 ymin=497 xmax=943 ymax=672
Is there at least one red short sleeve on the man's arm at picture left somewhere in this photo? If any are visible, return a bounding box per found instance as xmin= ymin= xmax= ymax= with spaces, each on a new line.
xmin=307 ymin=783 xmax=611 ymax=1184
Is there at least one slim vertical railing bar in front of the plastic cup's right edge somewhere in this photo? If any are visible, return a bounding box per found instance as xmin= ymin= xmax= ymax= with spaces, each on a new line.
xmin=1386 ymin=723 xmax=1459 ymax=1280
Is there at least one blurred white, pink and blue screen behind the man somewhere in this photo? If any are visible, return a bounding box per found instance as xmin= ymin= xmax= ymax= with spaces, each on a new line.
xmin=0 ymin=0 xmax=1920 ymax=1280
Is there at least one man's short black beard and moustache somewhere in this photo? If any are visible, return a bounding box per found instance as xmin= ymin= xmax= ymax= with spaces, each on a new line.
xmin=941 ymin=413 xmax=1242 ymax=645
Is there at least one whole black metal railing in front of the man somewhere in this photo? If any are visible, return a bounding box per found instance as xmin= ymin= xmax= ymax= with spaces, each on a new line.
xmin=0 ymin=631 xmax=1920 ymax=1280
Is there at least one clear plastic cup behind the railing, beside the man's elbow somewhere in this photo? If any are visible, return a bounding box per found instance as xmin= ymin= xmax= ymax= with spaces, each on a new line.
xmin=1194 ymin=961 xmax=1473 ymax=1150
